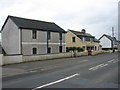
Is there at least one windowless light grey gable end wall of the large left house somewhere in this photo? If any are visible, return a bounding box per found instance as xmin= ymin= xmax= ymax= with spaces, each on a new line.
xmin=1 ymin=19 xmax=21 ymax=54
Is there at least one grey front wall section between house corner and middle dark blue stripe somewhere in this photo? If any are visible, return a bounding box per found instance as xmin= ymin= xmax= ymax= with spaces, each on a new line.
xmin=22 ymin=29 xmax=47 ymax=55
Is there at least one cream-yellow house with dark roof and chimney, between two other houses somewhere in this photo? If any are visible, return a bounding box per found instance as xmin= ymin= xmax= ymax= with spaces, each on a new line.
xmin=66 ymin=29 xmax=101 ymax=51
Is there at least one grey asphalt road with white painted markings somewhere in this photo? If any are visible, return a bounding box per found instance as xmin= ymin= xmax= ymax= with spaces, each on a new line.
xmin=3 ymin=53 xmax=120 ymax=90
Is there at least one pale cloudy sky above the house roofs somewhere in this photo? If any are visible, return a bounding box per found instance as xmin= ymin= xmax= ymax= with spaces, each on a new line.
xmin=0 ymin=0 xmax=119 ymax=39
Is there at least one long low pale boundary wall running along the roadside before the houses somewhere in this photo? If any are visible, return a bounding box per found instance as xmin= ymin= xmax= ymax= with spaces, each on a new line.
xmin=0 ymin=51 xmax=105 ymax=65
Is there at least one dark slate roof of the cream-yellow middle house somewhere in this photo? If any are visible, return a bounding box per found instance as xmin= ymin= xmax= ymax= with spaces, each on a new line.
xmin=68 ymin=29 xmax=99 ymax=42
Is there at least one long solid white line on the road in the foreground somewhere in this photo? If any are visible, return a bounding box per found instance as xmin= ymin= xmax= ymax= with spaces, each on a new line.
xmin=32 ymin=73 xmax=80 ymax=90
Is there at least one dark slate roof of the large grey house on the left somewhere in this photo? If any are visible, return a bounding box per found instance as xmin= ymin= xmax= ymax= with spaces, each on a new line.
xmin=2 ymin=16 xmax=66 ymax=33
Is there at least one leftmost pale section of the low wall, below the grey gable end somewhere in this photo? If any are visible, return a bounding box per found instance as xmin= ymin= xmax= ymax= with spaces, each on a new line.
xmin=3 ymin=55 xmax=23 ymax=65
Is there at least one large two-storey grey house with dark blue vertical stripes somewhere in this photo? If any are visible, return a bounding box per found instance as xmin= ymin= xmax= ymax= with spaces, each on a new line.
xmin=1 ymin=16 xmax=66 ymax=55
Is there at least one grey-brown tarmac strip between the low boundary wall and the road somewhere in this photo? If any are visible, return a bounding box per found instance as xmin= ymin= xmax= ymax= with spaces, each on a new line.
xmin=2 ymin=58 xmax=78 ymax=77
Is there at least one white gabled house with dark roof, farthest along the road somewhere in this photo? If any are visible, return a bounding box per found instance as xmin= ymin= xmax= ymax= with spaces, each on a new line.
xmin=98 ymin=34 xmax=118 ymax=50
